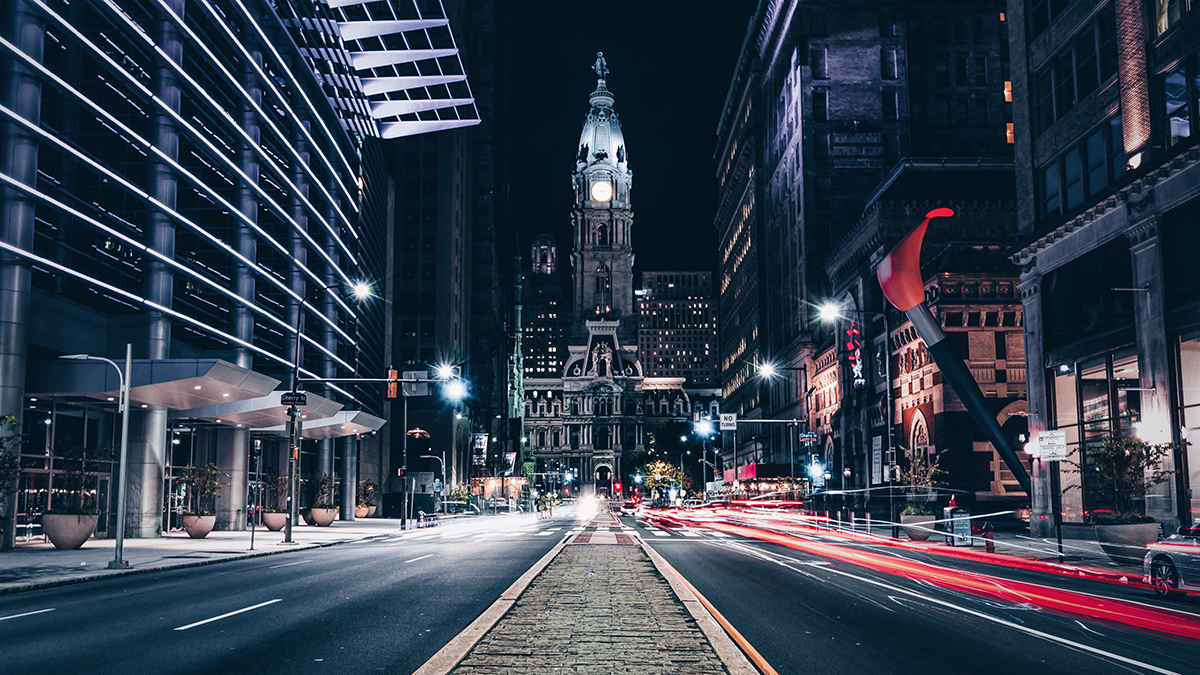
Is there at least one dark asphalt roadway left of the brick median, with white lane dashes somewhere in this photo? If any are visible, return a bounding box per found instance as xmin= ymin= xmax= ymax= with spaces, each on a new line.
xmin=0 ymin=514 xmax=575 ymax=675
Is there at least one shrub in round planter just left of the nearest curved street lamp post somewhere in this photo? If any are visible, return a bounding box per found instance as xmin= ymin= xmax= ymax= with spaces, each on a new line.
xmin=42 ymin=447 xmax=101 ymax=550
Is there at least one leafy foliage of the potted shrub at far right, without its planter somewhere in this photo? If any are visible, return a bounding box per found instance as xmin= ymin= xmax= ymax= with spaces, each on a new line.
xmin=1063 ymin=436 xmax=1188 ymax=521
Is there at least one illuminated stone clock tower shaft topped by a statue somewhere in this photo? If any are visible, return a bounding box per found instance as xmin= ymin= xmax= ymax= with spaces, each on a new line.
xmin=571 ymin=53 xmax=637 ymax=345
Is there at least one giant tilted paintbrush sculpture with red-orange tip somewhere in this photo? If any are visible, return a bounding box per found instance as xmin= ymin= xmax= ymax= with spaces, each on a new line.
xmin=877 ymin=209 xmax=1033 ymax=495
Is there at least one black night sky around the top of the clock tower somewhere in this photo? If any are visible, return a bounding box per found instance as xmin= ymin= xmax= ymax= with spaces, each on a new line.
xmin=509 ymin=0 xmax=756 ymax=278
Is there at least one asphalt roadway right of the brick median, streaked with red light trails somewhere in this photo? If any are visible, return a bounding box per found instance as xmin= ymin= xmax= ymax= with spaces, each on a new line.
xmin=626 ymin=511 xmax=1200 ymax=675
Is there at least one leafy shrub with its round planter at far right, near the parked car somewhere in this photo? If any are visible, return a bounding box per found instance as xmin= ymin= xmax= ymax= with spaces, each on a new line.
xmin=1064 ymin=436 xmax=1187 ymax=565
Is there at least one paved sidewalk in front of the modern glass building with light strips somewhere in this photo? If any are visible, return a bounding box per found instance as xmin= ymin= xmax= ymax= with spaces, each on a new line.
xmin=0 ymin=518 xmax=400 ymax=595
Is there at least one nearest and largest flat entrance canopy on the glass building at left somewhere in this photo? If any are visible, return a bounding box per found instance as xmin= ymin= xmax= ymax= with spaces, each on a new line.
xmin=25 ymin=359 xmax=280 ymax=410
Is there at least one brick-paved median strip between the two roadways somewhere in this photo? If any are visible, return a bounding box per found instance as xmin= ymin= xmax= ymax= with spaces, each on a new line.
xmin=452 ymin=534 xmax=727 ymax=675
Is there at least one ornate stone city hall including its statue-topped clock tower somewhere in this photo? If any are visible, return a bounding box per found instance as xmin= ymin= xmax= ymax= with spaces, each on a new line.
xmin=523 ymin=55 xmax=719 ymax=495
